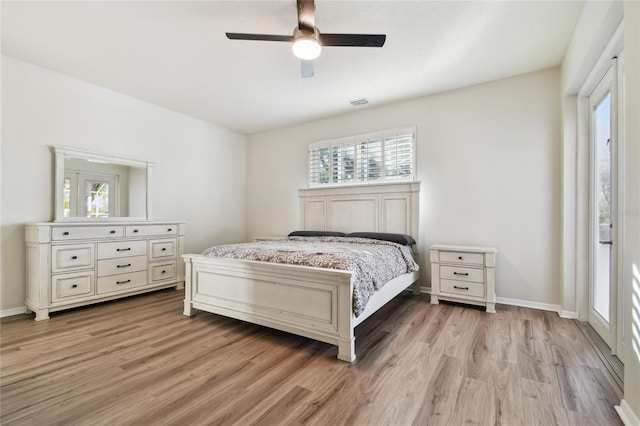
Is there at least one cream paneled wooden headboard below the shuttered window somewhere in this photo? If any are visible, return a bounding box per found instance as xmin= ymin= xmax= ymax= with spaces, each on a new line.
xmin=298 ymin=182 xmax=420 ymax=246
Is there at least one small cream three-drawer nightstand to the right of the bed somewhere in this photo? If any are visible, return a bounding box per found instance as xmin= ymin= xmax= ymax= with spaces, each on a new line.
xmin=429 ymin=244 xmax=497 ymax=313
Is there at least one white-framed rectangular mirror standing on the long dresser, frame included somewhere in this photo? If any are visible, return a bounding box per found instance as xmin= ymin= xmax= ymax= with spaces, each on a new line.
xmin=53 ymin=146 xmax=153 ymax=221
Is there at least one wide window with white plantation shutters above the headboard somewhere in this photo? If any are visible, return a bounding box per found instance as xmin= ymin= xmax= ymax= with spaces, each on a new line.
xmin=309 ymin=127 xmax=416 ymax=186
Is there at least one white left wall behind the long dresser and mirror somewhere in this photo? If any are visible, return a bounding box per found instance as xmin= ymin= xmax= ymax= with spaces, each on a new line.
xmin=0 ymin=56 xmax=245 ymax=310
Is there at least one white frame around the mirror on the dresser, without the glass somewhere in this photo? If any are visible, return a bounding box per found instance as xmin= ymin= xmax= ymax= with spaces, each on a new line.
xmin=53 ymin=146 xmax=154 ymax=222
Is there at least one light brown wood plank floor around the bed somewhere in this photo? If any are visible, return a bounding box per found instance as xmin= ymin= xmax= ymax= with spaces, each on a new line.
xmin=0 ymin=290 xmax=622 ymax=426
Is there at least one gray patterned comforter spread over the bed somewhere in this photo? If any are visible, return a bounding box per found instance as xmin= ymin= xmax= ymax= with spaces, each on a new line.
xmin=202 ymin=237 xmax=418 ymax=317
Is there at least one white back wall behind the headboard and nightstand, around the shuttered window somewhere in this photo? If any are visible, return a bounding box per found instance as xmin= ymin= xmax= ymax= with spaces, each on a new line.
xmin=247 ymin=69 xmax=561 ymax=305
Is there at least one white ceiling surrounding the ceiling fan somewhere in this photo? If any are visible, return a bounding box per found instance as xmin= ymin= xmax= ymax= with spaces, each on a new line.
xmin=1 ymin=0 xmax=583 ymax=133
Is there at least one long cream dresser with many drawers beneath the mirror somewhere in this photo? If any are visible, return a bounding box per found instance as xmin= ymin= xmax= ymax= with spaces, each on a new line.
xmin=25 ymin=221 xmax=185 ymax=321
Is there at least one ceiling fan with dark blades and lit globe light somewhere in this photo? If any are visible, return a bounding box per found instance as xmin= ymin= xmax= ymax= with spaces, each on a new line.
xmin=226 ymin=0 xmax=387 ymax=78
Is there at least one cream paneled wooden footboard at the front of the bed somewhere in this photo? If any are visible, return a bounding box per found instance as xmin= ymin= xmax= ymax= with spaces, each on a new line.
xmin=184 ymin=255 xmax=356 ymax=362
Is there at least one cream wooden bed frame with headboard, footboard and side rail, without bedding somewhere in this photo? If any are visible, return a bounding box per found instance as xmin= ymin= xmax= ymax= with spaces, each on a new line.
xmin=183 ymin=182 xmax=420 ymax=362
